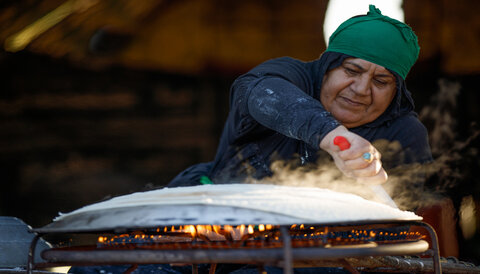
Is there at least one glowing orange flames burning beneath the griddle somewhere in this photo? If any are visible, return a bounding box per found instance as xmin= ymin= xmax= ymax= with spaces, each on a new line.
xmin=97 ymin=224 xmax=424 ymax=248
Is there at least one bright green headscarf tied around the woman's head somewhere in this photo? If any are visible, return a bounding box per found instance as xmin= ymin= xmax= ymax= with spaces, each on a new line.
xmin=326 ymin=5 xmax=420 ymax=79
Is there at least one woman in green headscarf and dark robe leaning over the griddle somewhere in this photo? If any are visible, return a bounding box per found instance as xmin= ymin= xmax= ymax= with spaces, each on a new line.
xmin=168 ymin=5 xmax=432 ymax=186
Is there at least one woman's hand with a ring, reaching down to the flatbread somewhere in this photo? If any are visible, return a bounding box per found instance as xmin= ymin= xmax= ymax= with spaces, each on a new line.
xmin=320 ymin=126 xmax=388 ymax=185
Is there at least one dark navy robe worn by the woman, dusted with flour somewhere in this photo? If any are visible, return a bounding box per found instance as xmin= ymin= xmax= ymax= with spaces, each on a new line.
xmin=168 ymin=52 xmax=432 ymax=187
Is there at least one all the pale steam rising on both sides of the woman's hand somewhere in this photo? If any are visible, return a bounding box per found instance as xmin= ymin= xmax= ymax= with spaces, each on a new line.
xmin=249 ymin=80 xmax=479 ymax=210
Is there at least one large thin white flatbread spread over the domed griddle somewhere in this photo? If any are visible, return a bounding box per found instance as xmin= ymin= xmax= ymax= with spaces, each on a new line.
xmin=55 ymin=184 xmax=422 ymax=223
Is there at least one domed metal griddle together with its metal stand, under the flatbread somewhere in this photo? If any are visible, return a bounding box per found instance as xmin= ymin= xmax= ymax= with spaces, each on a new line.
xmin=27 ymin=185 xmax=441 ymax=273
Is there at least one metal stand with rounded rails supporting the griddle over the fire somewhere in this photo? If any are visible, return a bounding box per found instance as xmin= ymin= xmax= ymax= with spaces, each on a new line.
xmin=27 ymin=221 xmax=442 ymax=274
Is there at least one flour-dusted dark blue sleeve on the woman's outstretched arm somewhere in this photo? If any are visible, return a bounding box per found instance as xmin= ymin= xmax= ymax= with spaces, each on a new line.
xmin=231 ymin=56 xmax=340 ymax=149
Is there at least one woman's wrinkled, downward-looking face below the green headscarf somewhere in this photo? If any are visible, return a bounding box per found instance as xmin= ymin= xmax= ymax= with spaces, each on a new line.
xmin=320 ymin=58 xmax=396 ymax=128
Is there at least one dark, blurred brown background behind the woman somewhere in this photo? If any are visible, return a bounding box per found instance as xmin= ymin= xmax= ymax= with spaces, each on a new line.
xmin=0 ymin=0 xmax=480 ymax=264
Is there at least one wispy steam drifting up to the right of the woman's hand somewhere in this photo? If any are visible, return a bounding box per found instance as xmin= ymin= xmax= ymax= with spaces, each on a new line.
xmin=374 ymin=79 xmax=480 ymax=210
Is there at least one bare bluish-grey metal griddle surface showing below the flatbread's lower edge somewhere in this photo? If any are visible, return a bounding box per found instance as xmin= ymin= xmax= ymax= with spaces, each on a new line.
xmin=34 ymin=205 xmax=305 ymax=233
